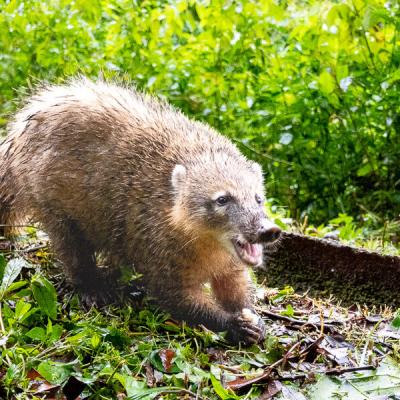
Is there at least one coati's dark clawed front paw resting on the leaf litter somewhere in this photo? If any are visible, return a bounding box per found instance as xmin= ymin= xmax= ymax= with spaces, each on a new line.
xmin=226 ymin=308 xmax=265 ymax=345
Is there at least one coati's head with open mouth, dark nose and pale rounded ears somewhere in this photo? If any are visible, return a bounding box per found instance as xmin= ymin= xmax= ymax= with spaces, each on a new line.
xmin=171 ymin=153 xmax=281 ymax=266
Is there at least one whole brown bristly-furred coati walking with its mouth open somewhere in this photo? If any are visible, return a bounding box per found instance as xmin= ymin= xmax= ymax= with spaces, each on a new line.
xmin=0 ymin=77 xmax=280 ymax=343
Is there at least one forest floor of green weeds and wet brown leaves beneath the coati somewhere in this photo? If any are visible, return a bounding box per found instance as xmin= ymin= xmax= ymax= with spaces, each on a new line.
xmin=0 ymin=228 xmax=400 ymax=400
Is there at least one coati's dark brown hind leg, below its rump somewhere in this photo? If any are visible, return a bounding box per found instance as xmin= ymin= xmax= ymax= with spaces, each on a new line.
xmin=44 ymin=213 xmax=115 ymax=306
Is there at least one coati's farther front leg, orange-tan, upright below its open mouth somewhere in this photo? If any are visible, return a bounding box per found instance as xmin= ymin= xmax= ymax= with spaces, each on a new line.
xmin=211 ymin=270 xmax=265 ymax=342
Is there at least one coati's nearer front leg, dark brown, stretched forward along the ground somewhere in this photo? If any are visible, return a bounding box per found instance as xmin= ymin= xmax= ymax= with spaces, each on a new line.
xmin=150 ymin=270 xmax=264 ymax=344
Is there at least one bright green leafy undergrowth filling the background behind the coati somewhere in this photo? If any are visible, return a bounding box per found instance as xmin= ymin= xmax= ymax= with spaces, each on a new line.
xmin=0 ymin=0 xmax=400 ymax=222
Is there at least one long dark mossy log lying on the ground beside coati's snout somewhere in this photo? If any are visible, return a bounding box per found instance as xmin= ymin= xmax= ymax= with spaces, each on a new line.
xmin=260 ymin=232 xmax=400 ymax=306
